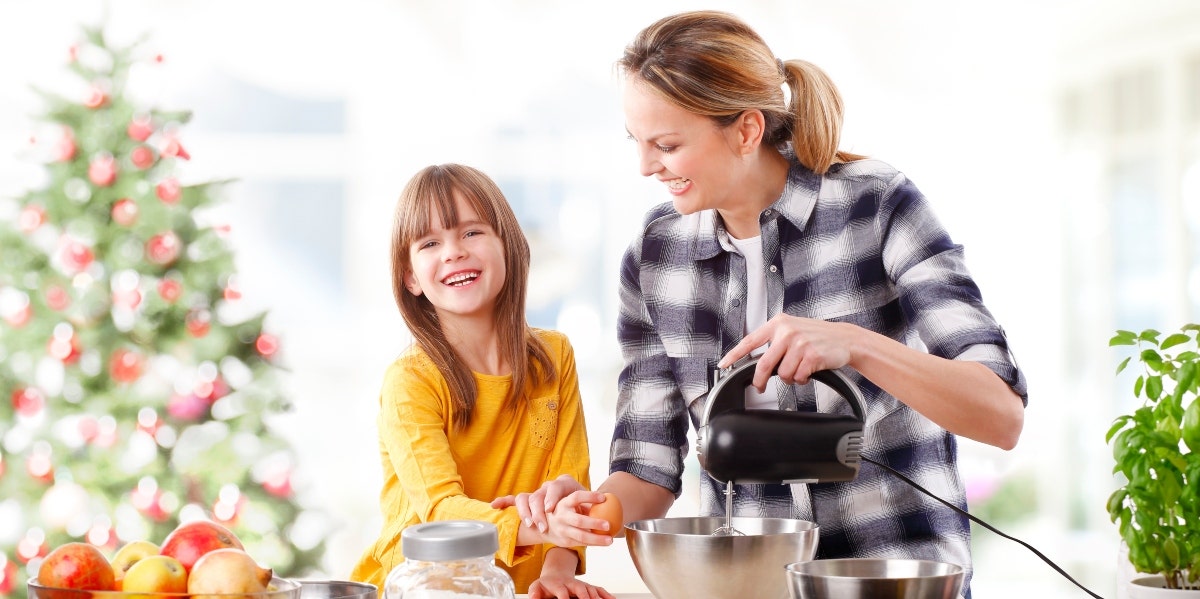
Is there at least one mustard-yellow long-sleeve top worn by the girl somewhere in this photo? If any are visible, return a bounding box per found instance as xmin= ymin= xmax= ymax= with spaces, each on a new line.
xmin=350 ymin=329 xmax=590 ymax=597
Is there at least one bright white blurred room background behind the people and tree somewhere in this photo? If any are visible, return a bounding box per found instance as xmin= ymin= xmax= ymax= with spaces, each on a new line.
xmin=0 ymin=0 xmax=1200 ymax=597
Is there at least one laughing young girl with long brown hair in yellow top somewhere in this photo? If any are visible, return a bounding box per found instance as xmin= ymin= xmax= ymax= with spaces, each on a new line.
xmin=350 ymin=164 xmax=612 ymax=599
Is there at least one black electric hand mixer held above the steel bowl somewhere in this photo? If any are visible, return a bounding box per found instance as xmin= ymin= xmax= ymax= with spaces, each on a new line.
xmin=696 ymin=359 xmax=866 ymax=486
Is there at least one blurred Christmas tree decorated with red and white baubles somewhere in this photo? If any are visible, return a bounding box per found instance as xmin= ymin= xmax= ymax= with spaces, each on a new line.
xmin=0 ymin=29 xmax=324 ymax=598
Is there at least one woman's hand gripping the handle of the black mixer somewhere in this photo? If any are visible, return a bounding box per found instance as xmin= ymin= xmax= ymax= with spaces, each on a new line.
xmin=718 ymin=315 xmax=862 ymax=393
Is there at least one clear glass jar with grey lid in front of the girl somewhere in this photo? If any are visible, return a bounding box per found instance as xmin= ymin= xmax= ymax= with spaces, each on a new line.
xmin=383 ymin=520 xmax=516 ymax=599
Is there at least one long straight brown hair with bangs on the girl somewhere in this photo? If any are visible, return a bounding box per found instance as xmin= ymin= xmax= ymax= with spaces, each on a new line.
xmin=391 ymin=164 xmax=556 ymax=429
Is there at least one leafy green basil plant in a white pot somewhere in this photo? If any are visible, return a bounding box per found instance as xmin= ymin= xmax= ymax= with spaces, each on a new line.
xmin=1105 ymin=324 xmax=1200 ymax=598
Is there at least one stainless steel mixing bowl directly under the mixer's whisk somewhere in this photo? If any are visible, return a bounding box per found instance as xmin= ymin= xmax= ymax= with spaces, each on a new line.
xmin=625 ymin=517 xmax=817 ymax=599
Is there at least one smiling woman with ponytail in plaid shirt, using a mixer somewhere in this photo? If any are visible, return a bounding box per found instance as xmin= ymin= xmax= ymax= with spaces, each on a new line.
xmin=515 ymin=12 xmax=1027 ymax=597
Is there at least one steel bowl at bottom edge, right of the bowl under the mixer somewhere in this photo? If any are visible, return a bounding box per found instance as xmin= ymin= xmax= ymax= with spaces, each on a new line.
xmin=787 ymin=558 xmax=962 ymax=599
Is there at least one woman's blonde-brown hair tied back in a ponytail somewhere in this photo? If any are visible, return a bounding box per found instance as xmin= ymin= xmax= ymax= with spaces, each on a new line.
xmin=617 ymin=11 xmax=863 ymax=174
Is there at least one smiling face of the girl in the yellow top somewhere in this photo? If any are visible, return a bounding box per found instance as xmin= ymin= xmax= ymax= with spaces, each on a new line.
xmin=404 ymin=192 xmax=506 ymax=328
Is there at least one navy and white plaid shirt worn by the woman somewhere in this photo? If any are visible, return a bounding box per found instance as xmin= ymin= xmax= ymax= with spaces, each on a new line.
xmin=610 ymin=154 xmax=1027 ymax=597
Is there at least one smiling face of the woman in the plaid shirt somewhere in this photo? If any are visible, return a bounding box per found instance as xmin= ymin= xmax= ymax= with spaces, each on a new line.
xmin=624 ymin=78 xmax=743 ymax=214
